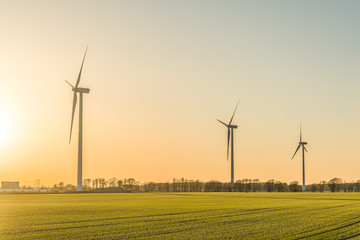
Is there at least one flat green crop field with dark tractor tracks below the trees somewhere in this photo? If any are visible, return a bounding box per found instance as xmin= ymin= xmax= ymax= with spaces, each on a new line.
xmin=0 ymin=193 xmax=360 ymax=239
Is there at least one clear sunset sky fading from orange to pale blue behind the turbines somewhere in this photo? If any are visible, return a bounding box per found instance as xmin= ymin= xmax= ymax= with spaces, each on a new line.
xmin=0 ymin=0 xmax=360 ymax=185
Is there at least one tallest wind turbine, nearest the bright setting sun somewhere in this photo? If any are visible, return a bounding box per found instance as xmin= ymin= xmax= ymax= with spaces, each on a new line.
xmin=65 ymin=47 xmax=90 ymax=191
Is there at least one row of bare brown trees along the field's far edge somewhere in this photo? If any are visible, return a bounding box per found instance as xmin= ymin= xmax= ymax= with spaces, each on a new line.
xmin=47 ymin=178 xmax=360 ymax=193
